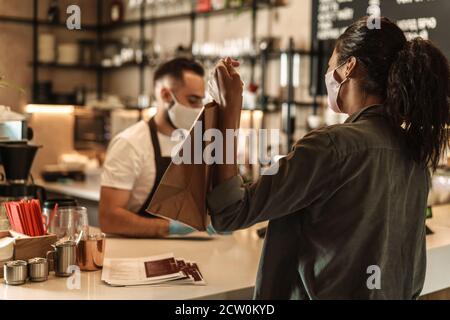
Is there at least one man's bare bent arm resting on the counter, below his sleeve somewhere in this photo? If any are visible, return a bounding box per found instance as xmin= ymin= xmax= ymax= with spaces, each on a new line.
xmin=99 ymin=187 xmax=169 ymax=238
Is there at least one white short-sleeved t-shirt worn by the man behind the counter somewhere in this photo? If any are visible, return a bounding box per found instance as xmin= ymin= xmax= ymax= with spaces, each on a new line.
xmin=101 ymin=121 xmax=177 ymax=212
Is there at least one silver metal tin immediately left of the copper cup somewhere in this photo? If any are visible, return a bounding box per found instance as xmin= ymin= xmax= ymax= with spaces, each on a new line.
xmin=47 ymin=240 xmax=78 ymax=277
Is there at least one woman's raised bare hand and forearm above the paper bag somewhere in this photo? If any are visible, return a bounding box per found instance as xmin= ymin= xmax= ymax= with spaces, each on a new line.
xmin=216 ymin=58 xmax=244 ymax=129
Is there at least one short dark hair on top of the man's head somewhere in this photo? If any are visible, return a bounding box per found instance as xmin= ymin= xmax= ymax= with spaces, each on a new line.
xmin=153 ymin=58 xmax=205 ymax=83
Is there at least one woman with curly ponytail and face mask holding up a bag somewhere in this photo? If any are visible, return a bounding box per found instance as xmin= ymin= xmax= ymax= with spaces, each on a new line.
xmin=208 ymin=18 xmax=450 ymax=299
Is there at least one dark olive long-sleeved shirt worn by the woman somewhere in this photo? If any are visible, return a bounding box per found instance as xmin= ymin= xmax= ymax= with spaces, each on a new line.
xmin=208 ymin=105 xmax=430 ymax=299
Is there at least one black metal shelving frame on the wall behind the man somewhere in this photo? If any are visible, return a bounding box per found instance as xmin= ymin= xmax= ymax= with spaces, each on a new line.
xmin=0 ymin=0 xmax=319 ymax=150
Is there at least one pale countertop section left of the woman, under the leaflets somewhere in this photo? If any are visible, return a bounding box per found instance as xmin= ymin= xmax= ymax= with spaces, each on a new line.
xmin=0 ymin=227 xmax=263 ymax=300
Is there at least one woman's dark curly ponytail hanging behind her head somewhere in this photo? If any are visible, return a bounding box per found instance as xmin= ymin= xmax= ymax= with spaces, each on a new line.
xmin=386 ymin=38 xmax=450 ymax=170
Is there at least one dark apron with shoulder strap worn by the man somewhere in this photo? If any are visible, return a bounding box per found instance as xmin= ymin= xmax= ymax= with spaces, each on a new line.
xmin=138 ymin=117 xmax=172 ymax=218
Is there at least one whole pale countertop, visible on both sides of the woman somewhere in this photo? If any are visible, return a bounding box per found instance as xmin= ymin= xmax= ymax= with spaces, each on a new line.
xmin=0 ymin=206 xmax=450 ymax=300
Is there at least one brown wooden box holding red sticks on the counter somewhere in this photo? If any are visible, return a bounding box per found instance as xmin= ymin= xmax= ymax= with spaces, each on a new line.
xmin=0 ymin=231 xmax=57 ymax=278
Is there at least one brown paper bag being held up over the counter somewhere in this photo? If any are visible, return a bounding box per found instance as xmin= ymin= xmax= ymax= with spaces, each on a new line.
xmin=147 ymin=102 xmax=219 ymax=231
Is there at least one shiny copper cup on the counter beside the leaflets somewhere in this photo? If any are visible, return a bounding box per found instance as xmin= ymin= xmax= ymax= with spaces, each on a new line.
xmin=77 ymin=233 xmax=106 ymax=271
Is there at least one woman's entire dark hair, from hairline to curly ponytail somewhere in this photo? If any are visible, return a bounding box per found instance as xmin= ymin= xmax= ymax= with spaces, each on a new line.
xmin=336 ymin=17 xmax=450 ymax=170
